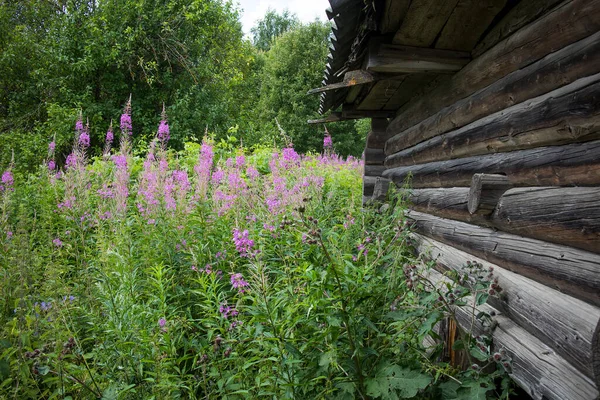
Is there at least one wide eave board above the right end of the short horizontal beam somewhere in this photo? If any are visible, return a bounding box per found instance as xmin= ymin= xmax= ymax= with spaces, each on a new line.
xmin=435 ymin=0 xmax=506 ymax=52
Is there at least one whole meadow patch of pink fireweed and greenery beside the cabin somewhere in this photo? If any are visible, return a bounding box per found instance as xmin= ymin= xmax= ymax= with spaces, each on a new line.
xmin=0 ymin=102 xmax=510 ymax=399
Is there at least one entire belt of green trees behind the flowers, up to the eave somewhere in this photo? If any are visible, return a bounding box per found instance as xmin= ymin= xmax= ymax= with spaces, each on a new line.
xmin=0 ymin=4 xmax=366 ymax=171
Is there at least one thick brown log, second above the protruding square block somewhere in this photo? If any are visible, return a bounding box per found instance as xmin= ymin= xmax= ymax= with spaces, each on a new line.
xmin=386 ymin=74 xmax=600 ymax=163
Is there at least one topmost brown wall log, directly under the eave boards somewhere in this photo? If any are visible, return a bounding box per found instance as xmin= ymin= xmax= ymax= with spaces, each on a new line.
xmin=388 ymin=0 xmax=600 ymax=139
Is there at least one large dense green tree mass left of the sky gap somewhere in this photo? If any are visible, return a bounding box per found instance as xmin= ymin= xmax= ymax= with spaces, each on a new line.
xmin=0 ymin=0 xmax=252 ymax=163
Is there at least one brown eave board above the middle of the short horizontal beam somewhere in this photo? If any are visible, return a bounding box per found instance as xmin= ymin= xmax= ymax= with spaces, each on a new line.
xmin=393 ymin=0 xmax=458 ymax=47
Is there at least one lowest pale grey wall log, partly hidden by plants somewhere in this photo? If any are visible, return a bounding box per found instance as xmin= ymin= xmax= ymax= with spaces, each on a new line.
xmin=428 ymin=271 xmax=598 ymax=400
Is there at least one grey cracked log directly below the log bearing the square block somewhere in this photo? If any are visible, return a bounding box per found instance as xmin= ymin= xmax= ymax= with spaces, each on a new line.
xmin=408 ymin=211 xmax=600 ymax=306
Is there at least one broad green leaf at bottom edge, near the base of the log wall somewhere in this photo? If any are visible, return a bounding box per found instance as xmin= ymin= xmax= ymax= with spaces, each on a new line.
xmin=366 ymin=365 xmax=431 ymax=399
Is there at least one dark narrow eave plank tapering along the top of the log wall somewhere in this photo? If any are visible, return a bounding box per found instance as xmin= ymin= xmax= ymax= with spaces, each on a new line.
xmin=473 ymin=0 xmax=562 ymax=58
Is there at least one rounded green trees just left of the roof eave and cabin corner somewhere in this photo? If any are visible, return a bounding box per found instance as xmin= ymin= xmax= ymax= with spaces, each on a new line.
xmin=253 ymin=21 xmax=364 ymax=155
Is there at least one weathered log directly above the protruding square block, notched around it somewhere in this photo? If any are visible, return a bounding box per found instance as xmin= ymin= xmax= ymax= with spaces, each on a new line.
xmin=383 ymin=140 xmax=600 ymax=188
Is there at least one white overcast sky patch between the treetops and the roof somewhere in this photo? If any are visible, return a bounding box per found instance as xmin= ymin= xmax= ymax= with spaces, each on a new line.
xmin=237 ymin=0 xmax=329 ymax=35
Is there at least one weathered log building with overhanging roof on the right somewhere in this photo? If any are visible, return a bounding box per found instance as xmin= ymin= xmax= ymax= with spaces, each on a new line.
xmin=313 ymin=0 xmax=600 ymax=400
